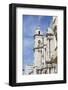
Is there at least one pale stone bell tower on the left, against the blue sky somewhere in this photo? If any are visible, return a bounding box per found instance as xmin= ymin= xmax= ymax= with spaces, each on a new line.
xmin=34 ymin=27 xmax=43 ymax=73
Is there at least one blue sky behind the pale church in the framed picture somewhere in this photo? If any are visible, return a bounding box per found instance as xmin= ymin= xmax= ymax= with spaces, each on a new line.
xmin=22 ymin=15 xmax=53 ymax=65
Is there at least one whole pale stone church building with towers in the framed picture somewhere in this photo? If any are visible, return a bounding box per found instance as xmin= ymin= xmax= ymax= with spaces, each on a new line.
xmin=22 ymin=17 xmax=58 ymax=74
